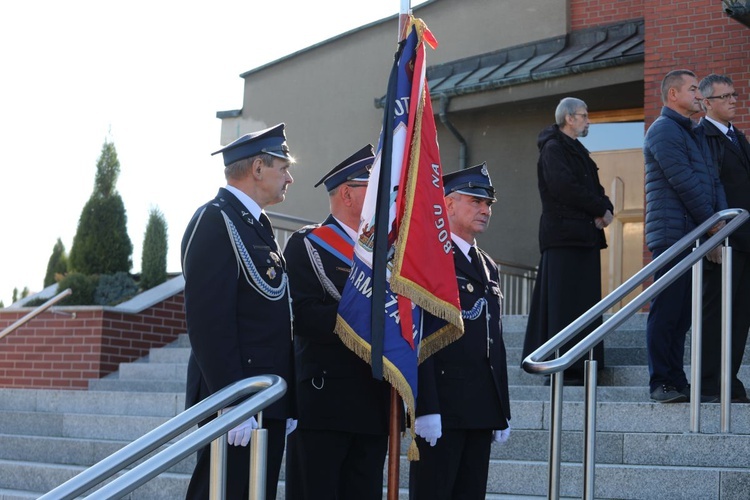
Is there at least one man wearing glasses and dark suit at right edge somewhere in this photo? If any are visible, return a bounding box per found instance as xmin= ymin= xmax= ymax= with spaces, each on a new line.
xmin=698 ymin=74 xmax=750 ymax=403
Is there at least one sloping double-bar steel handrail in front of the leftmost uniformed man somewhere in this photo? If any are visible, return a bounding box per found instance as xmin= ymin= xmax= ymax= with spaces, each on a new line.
xmin=39 ymin=375 xmax=287 ymax=500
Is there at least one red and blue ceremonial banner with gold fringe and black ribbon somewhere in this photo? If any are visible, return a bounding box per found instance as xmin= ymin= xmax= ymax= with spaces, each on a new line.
xmin=336 ymin=17 xmax=463 ymax=454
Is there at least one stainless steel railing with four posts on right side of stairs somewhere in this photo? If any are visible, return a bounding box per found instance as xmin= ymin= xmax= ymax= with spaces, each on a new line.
xmin=523 ymin=209 xmax=750 ymax=499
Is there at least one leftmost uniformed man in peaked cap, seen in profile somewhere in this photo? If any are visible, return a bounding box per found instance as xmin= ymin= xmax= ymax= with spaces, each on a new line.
xmin=182 ymin=123 xmax=294 ymax=500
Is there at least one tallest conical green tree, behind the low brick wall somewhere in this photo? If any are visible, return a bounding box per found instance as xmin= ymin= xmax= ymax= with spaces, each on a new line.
xmin=68 ymin=141 xmax=133 ymax=275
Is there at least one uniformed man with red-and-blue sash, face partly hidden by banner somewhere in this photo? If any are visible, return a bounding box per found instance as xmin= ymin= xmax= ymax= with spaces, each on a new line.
xmin=284 ymin=144 xmax=390 ymax=500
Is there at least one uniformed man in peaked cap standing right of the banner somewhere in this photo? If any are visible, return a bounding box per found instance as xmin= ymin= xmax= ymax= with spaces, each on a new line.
xmin=409 ymin=164 xmax=510 ymax=500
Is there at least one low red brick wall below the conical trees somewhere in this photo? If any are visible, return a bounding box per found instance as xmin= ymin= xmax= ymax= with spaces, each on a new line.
xmin=0 ymin=292 xmax=187 ymax=389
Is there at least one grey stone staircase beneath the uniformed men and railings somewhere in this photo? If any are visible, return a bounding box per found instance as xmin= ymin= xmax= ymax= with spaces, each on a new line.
xmin=0 ymin=315 xmax=750 ymax=500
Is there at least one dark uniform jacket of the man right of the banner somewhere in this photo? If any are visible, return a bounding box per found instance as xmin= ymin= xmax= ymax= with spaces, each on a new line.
xmin=416 ymin=242 xmax=510 ymax=430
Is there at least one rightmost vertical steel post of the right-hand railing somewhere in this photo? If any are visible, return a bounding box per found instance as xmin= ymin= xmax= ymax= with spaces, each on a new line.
xmin=719 ymin=238 xmax=736 ymax=432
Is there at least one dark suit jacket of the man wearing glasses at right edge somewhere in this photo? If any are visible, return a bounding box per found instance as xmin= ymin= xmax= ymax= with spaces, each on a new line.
xmin=697 ymin=120 xmax=750 ymax=252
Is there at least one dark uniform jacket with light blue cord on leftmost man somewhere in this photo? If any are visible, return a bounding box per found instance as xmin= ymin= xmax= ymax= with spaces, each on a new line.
xmin=182 ymin=188 xmax=293 ymax=419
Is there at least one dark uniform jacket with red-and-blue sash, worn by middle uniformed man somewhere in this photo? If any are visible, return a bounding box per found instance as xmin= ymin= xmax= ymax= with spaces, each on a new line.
xmin=284 ymin=216 xmax=390 ymax=434
